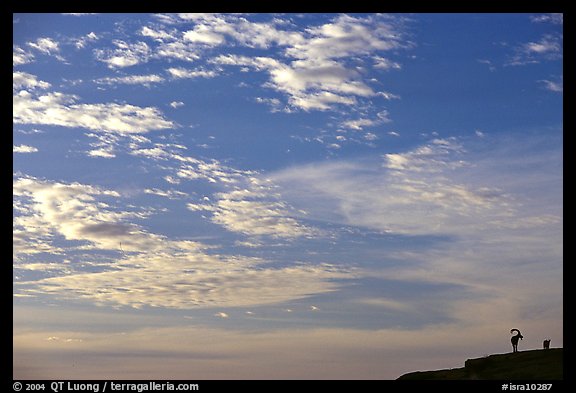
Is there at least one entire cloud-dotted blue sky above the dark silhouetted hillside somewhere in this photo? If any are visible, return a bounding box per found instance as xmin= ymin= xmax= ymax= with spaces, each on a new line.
xmin=13 ymin=13 xmax=563 ymax=380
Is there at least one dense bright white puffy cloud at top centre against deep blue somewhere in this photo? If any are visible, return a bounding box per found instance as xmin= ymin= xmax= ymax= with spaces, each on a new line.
xmin=212 ymin=16 xmax=404 ymax=111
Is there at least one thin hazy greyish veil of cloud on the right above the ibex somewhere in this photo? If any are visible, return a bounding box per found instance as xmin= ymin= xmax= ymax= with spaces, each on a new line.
xmin=270 ymin=133 xmax=563 ymax=352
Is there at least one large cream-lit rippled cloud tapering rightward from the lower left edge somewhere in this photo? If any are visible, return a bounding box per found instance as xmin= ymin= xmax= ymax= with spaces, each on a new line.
xmin=13 ymin=177 xmax=350 ymax=309
